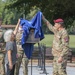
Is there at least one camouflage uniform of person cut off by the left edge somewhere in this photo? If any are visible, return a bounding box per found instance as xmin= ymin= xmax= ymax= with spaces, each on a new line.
xmin=0 ymin=28 xmax=5 ymax=75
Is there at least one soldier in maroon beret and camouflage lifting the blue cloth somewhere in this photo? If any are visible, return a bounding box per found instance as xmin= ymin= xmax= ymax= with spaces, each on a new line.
xmin=42 ymin=16 xmax=69 ymax=75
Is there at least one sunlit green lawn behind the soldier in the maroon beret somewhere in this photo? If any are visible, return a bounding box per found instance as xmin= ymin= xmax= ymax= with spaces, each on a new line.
xmin=35 ymin=34 xmax=75 ymax=48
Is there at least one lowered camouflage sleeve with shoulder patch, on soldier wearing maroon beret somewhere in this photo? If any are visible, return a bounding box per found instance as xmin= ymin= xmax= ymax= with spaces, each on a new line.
xmin=61 ymin=33 xmax=69 ymax=57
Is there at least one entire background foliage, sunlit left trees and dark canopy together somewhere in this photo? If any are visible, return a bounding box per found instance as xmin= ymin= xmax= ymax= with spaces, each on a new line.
xmin=0 ymin=0 xmax=75 ymax=33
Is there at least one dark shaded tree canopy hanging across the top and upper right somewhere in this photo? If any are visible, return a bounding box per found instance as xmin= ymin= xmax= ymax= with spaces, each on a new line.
xmin=6 ymin=0 xmax=75 ymax=28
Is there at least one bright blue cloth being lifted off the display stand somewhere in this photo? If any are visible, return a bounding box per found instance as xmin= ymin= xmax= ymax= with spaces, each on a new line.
xmin=20 ymin=11 xmax=44 ymax=59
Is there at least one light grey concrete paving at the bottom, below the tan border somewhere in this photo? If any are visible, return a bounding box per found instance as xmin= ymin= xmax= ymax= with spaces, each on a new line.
xmin=19 ymin=64 xmax=75 ymax=75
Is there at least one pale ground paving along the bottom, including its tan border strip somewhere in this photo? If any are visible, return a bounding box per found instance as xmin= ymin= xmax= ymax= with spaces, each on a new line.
xmin=19 ymin=62 xmax=75 ymax=75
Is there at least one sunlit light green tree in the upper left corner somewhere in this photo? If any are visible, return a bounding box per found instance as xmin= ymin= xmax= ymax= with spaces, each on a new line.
xmin=0 ymin=0 xmax=21 ymax=24
